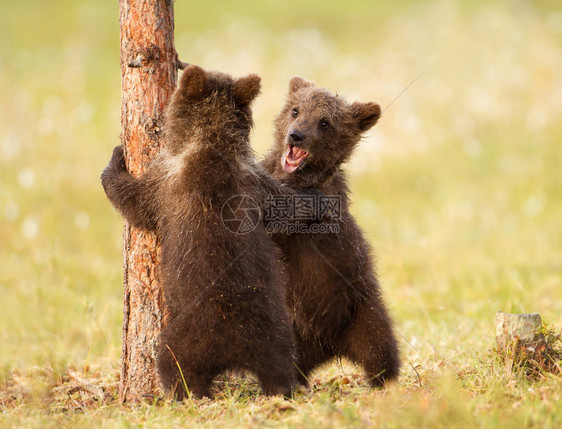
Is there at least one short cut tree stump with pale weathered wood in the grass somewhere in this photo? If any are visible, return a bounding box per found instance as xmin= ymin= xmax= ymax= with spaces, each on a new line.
xmin=496 ymin=311 xmax=546 ymax=359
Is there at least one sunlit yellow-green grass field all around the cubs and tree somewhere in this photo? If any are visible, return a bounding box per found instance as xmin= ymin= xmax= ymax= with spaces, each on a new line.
xmin=0 ymin=0 xmax=562 ymax=428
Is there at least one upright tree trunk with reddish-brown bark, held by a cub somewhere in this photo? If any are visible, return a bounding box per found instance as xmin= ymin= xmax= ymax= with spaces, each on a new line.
xmin=119 ymin=0 xmax=178 ymax=402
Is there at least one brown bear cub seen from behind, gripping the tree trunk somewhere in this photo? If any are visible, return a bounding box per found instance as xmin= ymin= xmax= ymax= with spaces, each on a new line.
xmin=102 ymin=66 xmax=297 ymax=399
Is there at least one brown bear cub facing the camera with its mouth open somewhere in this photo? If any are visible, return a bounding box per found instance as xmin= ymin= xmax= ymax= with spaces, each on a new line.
xmin=262 ymin=77 xmax=400 ymax=386
